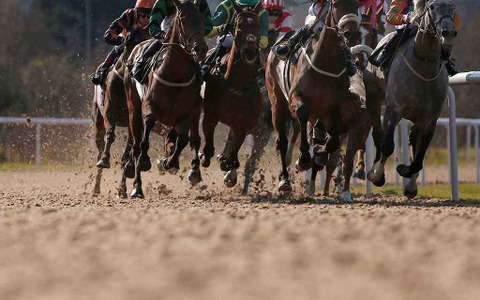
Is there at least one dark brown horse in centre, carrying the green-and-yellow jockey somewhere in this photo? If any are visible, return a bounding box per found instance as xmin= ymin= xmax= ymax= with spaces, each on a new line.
xmin=202 ymin=2 xmax=262 ymax=187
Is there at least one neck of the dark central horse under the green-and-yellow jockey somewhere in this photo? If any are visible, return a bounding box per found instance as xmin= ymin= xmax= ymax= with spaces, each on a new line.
xmin=225 ymin=42 xmax=258 ymax=89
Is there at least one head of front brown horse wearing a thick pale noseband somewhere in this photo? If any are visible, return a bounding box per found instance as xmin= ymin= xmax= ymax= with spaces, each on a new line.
xmin=327 ymin=0 xmax=360 ymax=46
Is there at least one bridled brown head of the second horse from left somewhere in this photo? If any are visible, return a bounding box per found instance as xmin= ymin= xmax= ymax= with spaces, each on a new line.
xmin=170 ymin=0 xmax=208 ymax=62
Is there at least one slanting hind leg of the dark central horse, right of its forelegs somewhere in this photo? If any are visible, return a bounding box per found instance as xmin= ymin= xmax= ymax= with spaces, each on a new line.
xmin=242 ymin=123 xmax=272 ymax=195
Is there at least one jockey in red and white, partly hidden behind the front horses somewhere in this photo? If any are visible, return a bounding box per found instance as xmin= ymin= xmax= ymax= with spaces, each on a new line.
xmin=263 ymin=0 xmax=293 ymax=37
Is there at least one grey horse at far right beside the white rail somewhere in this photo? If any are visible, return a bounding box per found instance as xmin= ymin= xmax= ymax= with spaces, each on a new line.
xmin=367 ymin=0 xmax=457 ymax=198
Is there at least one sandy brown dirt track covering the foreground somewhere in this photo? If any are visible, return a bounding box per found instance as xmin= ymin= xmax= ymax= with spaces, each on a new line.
xmin=0 ymin=171 xmax=480 ymax=299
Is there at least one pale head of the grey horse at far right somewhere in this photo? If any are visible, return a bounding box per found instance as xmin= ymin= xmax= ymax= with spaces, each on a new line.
xmin=415 ymin=0 xmax=457 ymax=48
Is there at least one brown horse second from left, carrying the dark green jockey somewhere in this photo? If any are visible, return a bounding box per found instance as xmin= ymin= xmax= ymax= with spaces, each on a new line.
xmin=128 ymin=0 xmax=208 ymax=198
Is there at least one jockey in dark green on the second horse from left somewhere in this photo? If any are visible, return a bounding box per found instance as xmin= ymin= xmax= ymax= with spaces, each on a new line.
xmin=132 ymin=0 xmax=212 ymax=82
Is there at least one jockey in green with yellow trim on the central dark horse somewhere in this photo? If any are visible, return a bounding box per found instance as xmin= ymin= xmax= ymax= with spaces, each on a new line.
xmin=202 ymin=0 xmax=268 ymax=75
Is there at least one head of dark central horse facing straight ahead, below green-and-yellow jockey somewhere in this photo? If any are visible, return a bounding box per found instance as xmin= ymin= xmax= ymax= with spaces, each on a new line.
xmin=233 ymin=1 xmax=262 ymax=64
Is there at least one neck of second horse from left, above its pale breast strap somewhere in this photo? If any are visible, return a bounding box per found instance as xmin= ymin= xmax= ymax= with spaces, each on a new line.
xmin=160 ymin=17 xmax=196 ymax=79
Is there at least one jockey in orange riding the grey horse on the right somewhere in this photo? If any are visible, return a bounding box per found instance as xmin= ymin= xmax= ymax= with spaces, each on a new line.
xmin=370 ymin=0 xmax=459 ymax=76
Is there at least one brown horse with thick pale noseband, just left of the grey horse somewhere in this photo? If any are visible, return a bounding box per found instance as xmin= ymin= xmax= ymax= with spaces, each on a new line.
xmin=266 ymin=0 xmax=366 ymax=201
